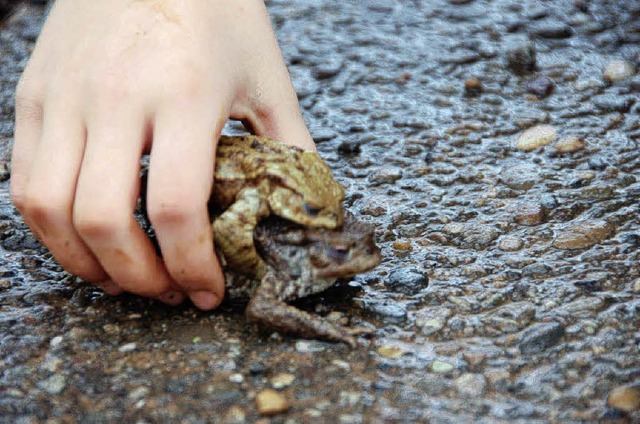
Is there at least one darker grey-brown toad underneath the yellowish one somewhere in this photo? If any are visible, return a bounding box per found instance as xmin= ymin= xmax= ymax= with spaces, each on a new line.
xmin=225 ymin=213 xmax=381 ymax=347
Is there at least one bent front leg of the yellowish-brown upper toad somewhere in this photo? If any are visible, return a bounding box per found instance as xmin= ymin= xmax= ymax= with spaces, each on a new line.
xmin=213 ymin=188 xmax=269 ymax=277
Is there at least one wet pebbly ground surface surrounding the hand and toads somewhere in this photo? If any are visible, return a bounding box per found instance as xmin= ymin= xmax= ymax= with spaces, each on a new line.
xmin=0 ymin=0 xmax=640 ymax=423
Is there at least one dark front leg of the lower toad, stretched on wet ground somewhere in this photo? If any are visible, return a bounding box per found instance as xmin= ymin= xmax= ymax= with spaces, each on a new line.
xmin=247 ymin=272 xmax=357 ymax=347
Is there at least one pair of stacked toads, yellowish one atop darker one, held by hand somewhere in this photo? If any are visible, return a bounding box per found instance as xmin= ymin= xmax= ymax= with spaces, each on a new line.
xmin=144 ymin=136 xmax=381 ymax=346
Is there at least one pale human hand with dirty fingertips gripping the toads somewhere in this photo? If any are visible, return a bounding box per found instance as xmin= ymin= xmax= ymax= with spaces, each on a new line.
xmin=11 ymin=0 xmax=315 ymax=310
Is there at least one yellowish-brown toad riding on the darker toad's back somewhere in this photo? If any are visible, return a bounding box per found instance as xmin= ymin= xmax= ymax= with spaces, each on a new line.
xmin=210 ymin=136 xmax=344 ymax=275
